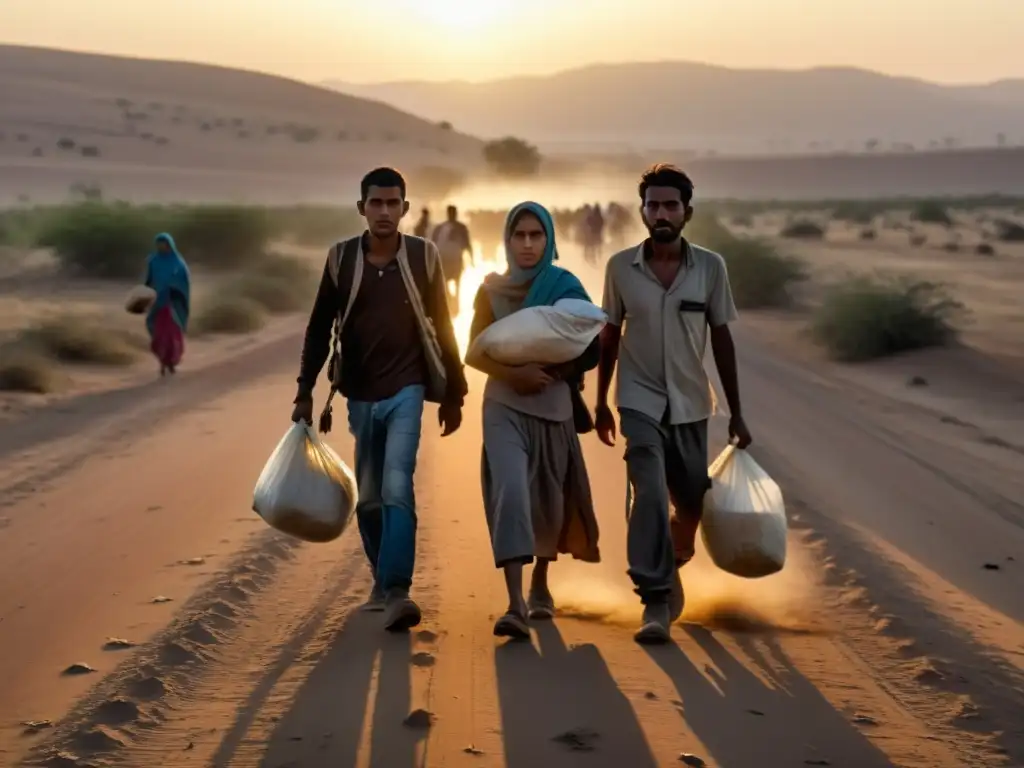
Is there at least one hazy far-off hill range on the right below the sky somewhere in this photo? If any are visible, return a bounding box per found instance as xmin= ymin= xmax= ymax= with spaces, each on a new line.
xmin=328 ymin=61 xmax=1024 ymax=153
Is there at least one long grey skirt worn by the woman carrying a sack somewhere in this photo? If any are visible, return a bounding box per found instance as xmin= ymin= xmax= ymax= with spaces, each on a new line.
xmin=481 ymin=399 xmax=601 ymax=567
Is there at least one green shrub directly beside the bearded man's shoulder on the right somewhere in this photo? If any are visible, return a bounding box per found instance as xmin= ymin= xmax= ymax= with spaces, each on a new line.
xmin=686 ymin=214 xmax=806 ymax=309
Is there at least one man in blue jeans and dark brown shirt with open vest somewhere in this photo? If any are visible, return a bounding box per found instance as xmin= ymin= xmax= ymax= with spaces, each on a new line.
xmin=292 ymin=168 xmax=467 ymax=631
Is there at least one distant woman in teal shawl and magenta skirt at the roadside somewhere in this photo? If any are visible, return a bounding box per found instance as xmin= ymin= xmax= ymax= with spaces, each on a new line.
xmin=145 ymin=232 xmax=191 ymax=376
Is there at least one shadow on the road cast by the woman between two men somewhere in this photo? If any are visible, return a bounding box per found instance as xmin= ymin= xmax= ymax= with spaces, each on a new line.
xmin=495 ymin=622 xmax=657 ymax=768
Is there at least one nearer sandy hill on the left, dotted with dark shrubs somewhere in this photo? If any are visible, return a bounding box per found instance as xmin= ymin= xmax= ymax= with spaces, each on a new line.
xmin=0 ymin=45 xmax=482 ymax=200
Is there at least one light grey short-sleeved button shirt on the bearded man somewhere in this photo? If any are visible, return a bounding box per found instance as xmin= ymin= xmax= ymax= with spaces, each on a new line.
xmin=603 ymin=243 xmax=737 ymax=424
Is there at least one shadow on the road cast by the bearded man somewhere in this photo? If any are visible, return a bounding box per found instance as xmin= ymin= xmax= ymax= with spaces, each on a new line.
xmin=646 ymin=627 xmax=893 ymax=768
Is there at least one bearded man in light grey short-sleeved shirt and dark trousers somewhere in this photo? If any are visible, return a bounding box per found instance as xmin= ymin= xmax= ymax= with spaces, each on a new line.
xmin=595 ymin=165 xmax=751 ymax=643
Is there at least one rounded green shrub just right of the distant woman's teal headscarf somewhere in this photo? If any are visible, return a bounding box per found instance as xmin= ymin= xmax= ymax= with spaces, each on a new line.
xmin=175 ymin=205 xmax=271 ymax=269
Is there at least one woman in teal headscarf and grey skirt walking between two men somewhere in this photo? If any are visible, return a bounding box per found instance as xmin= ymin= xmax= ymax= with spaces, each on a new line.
xmin=466 ymin=203 xmax=600 ymax=639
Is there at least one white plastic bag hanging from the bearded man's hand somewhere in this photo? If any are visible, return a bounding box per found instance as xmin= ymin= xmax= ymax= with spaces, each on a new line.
xmin=700 ymin=445 xmax=787 ymax=579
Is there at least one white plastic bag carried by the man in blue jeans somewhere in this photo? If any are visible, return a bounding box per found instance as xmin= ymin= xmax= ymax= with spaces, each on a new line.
xmin=253 ymin=422 xmax=358 ymax=542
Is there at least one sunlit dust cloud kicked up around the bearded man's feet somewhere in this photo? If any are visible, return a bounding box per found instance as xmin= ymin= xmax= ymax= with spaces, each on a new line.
xmin=551 ymin=537 xmax=825 ymax=634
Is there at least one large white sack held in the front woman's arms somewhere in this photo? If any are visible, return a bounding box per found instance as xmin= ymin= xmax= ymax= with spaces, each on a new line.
xmin=466 ymin=299 xmax=608 ymax=366
